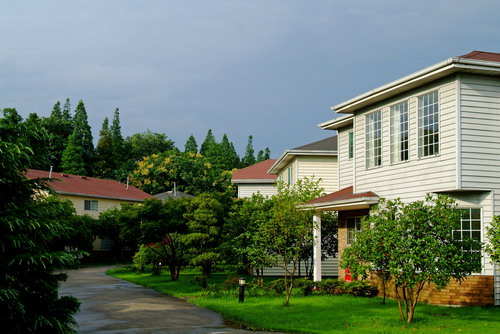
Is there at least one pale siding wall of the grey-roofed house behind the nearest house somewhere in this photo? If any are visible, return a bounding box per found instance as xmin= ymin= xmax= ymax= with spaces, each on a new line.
xmin=297 ymin=156 xmax=339 ymax=194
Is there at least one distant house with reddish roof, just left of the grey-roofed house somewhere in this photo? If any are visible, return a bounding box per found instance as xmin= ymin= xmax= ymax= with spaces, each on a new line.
xmin=231 ymin=159 xmax=276 ymax=198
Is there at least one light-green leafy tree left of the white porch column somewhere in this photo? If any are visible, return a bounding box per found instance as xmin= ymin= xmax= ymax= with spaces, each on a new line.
xmin=257 ymin=178 xmax=322 ymax=306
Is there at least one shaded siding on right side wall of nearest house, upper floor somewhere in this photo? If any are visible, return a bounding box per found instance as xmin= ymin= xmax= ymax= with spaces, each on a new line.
xmin=460 ymin=75 xmax=500 ymax=191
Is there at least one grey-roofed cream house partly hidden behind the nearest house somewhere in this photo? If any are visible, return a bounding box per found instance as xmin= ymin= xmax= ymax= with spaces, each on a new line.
xmin=269 ymin=136 xmax=339 ymax=193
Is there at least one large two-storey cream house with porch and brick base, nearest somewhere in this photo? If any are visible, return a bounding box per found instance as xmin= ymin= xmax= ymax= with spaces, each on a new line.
xmin=306 ymin=51 xmax=500 ymax=305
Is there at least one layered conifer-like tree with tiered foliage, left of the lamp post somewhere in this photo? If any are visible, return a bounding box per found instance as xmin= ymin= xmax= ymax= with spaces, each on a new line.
xmin=184 ymin=194 xmax=224 ymax=288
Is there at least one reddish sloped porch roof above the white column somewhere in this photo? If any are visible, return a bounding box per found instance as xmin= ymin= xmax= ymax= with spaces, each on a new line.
xmin=301 ymin=186 xmax=379 ymax=211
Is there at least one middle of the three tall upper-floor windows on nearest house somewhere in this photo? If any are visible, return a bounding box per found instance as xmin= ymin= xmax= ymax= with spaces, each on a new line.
xmin=390 ymin=101 xmax=408 ymax=163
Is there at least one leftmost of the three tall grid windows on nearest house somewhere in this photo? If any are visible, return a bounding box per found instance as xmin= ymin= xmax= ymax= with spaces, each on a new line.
xmin=365 ymin=111 xmax=382 ymax=168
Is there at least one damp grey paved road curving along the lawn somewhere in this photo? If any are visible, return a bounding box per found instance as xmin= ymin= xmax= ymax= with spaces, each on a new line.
xmin=59 ymin=267 xmax=280 ymax=334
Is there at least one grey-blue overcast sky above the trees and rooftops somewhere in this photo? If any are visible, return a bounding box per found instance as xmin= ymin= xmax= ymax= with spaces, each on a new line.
xmin=0 ymin=0 xmax=500 ymax=158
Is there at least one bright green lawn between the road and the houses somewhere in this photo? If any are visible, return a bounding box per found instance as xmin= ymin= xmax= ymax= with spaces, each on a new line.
xmin=110 ymin=270 xmax=500 ymax=334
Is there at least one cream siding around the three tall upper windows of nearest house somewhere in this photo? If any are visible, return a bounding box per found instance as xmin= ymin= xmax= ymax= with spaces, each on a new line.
xmin=352 ymin=78 xmax=456 ymax=201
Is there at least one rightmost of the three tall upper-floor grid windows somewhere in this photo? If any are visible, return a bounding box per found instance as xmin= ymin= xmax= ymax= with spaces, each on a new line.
xmin=418 ymin=91 xmax=439 ymax=157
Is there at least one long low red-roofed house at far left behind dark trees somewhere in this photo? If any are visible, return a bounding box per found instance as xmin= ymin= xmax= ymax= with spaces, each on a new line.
xmin=26 ymin=169 xmax=153 ymax=250
